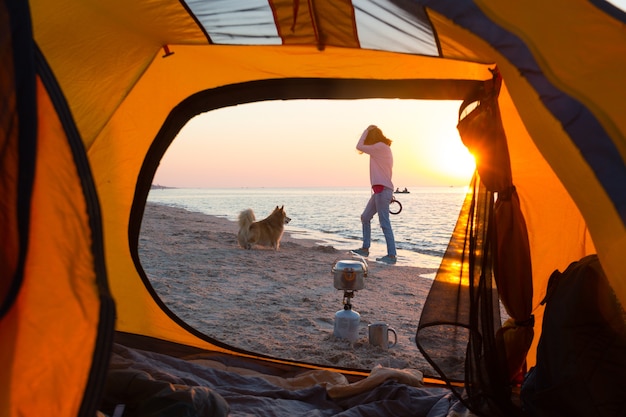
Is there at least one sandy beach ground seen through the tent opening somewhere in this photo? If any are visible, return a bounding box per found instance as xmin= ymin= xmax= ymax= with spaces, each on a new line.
xmin=139 ymin=203 xmax=435 ymax=375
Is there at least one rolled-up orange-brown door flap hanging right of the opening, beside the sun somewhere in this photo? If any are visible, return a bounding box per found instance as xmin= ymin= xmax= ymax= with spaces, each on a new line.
xmin=458 ymin=69 xmax=534 ymax=380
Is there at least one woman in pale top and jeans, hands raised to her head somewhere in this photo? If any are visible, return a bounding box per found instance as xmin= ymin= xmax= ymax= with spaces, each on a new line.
xmin=352 ymin=125 xmax=397 ymax=264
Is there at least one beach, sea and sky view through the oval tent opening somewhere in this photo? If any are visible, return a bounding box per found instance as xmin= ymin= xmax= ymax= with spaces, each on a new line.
xmin=138 ymin=99 xmax=482 ymax=376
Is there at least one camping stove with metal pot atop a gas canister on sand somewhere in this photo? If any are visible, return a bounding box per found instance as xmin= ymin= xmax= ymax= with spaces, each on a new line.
xmin=332 ymin=260 xmax=367 ymax=343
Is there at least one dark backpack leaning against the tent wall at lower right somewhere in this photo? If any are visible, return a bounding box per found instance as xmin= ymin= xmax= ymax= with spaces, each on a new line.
xmin=521 ymin=255 xmax=626 ymax=417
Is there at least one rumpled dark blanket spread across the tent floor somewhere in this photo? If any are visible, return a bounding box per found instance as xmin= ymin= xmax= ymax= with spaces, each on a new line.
xmin=101 ymin=344 xmax=471 ymax=417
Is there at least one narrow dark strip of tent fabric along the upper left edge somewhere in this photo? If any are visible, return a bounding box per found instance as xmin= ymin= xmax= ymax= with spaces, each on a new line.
xmin=0 ymin=0 xmax=37 ymax=317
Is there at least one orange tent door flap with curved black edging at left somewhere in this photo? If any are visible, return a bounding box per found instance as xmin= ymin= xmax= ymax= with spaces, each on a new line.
xmin=0 ymin=20 xmax=114 ymax=415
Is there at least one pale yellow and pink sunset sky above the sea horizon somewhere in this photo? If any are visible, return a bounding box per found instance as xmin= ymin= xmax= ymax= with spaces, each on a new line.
xmin=153 ymin=99 xmax=474 ymax=188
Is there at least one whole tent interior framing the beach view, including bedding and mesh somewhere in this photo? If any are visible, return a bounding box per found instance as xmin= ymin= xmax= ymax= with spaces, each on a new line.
xmin=0 ymin=0 xmax=626 ymax=416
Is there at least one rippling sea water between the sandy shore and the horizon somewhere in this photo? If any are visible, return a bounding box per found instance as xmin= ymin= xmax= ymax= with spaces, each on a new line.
xmin=148 ymin=187 xmax=467 ymax=268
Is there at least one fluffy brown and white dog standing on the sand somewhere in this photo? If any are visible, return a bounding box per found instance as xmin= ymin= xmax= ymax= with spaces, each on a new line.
xmin=237 ymin=205 xmax=291 ymax=250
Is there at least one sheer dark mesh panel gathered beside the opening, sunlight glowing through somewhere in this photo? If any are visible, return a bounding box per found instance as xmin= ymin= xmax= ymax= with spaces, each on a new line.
xmin=415 ymin=174 xmax=521 ymax=417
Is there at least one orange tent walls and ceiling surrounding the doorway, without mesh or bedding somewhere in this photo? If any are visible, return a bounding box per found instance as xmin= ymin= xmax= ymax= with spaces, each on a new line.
xmin=0 ymin=0 xmax=626 ymax=415
